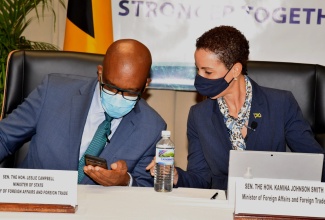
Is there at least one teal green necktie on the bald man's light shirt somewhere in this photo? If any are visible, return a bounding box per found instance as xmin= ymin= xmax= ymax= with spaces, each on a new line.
xmin=78 ymin=112 xmax=113 ymax=183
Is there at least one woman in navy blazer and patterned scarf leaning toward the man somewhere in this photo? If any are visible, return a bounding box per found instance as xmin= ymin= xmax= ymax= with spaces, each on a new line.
xmin=147 ymin=26 xmax=324 ymax=189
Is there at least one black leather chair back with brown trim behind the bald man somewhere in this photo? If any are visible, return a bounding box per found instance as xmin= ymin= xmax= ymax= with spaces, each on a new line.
xmin=0 ymin=50 xmax=104 ymax=167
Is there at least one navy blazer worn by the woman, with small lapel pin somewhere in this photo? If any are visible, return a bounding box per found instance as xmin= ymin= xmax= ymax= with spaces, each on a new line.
xmin=177 ymin=79 xmax=325 ymax=189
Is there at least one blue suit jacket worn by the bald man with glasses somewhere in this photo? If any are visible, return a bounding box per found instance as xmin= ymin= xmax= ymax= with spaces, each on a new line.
xmin=0 ymin=74 xmax=166 ymax=186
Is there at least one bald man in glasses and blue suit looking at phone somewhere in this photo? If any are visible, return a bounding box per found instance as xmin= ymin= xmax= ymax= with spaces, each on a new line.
xmin=0 ymin=39 xmax=166 ymax=186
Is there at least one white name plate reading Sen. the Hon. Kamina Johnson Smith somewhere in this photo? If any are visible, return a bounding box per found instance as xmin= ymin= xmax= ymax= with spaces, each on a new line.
xmin=235 ymin=178 xmax=325 ymax=217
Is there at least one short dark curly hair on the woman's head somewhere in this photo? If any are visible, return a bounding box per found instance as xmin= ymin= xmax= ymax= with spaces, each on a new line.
xmin=196 ymin=26 xmax=249 ymax=74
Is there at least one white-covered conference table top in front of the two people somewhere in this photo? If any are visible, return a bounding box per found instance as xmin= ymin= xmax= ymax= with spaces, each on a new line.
xmin=0 ymin=185 xmax=233 ymax=220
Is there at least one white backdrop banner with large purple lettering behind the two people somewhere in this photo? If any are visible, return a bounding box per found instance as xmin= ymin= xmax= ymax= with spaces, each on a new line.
xmin=112 ymin=0 xmax=325 ymax=90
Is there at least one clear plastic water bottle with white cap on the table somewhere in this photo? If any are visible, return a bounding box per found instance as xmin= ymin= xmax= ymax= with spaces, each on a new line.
xmin=155 ymin=131 xmax=175 ymax=192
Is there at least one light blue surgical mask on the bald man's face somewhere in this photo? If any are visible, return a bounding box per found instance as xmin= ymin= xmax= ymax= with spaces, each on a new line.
xmin=101 ymin=91 xmax=137 ymax=118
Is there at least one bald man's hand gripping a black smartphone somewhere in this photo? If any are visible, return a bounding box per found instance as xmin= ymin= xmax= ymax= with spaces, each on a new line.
xmin=84 ymin=160 xmax=130 ymax=186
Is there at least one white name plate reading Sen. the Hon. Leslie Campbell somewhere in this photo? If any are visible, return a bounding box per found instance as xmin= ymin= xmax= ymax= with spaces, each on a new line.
xmin=0 ymin=168 xmax=78 ymax=206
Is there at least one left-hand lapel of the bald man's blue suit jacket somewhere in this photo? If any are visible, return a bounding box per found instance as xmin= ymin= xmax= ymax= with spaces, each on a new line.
xmin=69 ymin=80 xmax=97 ymax=170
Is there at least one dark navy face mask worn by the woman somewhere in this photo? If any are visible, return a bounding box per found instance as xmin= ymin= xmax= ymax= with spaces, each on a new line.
xmin=194 ymin=67 xmax=233 ymax=97
